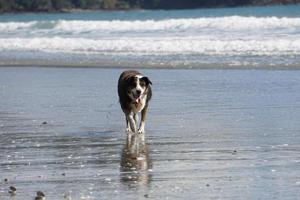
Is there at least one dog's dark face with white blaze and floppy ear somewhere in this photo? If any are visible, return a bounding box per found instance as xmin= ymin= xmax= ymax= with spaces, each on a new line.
xmin=127 ymin=75 xmax=152 ymax=103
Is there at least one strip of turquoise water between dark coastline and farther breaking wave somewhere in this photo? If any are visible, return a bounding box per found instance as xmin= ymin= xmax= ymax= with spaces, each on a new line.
xmin=0 ymin=5 xmax=300 ymax=22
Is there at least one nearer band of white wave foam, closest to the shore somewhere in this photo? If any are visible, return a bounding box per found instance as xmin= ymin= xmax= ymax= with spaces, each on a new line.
xmin=0 ymin=37 xmax=300 ymax=55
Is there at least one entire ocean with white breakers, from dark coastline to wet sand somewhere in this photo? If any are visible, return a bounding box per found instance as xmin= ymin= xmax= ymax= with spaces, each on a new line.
xmin=0 ymin=5 xmax=300 ymax=69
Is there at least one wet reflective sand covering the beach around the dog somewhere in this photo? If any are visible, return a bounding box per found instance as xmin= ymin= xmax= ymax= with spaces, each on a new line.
xmin=0 ymin=67 xmax=300 ymax=200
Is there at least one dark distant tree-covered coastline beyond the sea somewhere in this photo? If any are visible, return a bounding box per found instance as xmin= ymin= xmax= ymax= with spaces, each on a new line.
xmin=0 ymin=0 xmax=300 ymax=14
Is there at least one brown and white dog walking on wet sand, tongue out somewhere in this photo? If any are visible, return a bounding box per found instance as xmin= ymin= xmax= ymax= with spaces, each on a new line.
xmin=118 ymin=70 xmax=152 ymax=133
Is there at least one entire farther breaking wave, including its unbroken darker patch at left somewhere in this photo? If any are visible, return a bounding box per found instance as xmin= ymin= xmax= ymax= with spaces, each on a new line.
xmin=0 ymin=16 xmax=300 ymax=32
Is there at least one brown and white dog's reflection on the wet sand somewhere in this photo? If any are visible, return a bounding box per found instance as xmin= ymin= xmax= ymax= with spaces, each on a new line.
xmin=121 ymin=133 xmax=152 ymax=184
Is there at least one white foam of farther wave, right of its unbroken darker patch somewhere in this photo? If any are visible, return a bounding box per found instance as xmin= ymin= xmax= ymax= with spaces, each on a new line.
xmin=55 ymin=16 xmax=300 ymax=31
